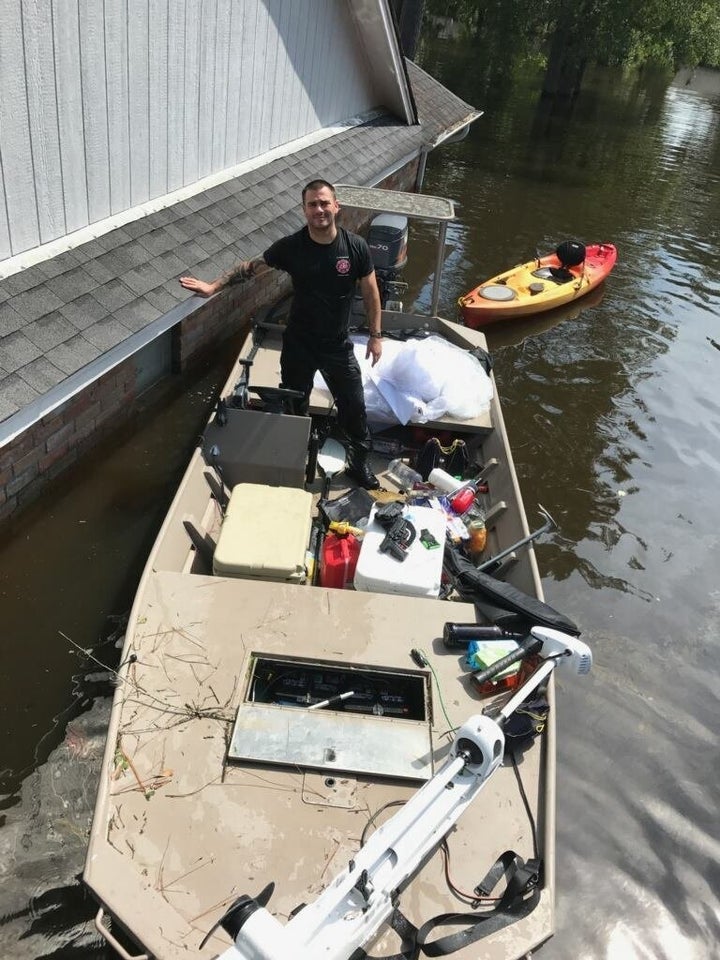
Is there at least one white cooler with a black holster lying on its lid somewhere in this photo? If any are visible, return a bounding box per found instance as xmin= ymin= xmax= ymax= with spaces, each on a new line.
xmin=353 ymin=505 xmax=445 ymax=597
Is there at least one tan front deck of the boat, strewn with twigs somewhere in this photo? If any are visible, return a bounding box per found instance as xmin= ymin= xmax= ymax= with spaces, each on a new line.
xmin=88 ymin=572 xmax=552 ymax=958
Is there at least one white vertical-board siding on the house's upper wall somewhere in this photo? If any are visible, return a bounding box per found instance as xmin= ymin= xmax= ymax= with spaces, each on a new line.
xmin=0 ymin=0 xmax=379 ymax=262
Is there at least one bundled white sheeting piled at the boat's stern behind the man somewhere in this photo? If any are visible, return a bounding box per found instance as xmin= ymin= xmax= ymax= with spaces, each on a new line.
xmin=316 ymin=335 xmax=493 ymax=424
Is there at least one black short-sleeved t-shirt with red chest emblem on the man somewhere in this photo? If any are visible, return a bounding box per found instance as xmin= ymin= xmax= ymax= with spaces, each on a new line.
xmin=263 ymin=227 xmax=375 ymax=340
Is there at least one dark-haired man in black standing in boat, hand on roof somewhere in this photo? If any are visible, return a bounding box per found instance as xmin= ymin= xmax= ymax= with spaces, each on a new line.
xmin=180 ymin=180 xmax=382 ymax=490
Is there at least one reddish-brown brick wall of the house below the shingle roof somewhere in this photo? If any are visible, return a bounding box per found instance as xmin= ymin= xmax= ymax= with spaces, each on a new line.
xmin=0 ymin=161 xmax=418 ymax=524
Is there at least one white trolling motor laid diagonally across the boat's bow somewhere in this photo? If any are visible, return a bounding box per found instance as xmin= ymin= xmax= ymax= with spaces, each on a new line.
xmin=201 ymin=627 xmax=592 ymax=960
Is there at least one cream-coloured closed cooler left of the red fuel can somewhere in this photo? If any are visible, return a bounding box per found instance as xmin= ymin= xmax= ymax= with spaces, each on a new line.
xmin=213 ymin=483 xmax=312 ymax=583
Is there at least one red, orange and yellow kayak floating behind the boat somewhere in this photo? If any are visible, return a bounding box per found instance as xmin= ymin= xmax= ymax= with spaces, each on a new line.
xmin=458 ymin=240 xmax=617 ymax=327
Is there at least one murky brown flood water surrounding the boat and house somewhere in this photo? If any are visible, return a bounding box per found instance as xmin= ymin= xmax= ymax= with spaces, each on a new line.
xmin=0 ymin=50 xmax=720 ymax=960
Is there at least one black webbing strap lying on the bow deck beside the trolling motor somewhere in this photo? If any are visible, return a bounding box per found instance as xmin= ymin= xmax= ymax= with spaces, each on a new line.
xmin=350 ymin=850 xmax=541 ymax=960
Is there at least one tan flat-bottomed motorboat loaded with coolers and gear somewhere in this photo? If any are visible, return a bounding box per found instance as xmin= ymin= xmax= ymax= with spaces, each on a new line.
xmin=84 ymin=187 xmax=589 ymax=960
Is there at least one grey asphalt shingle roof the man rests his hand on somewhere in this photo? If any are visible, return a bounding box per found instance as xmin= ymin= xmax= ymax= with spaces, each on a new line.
xmin=0 ymin=62 xmax=479 ymax=443
